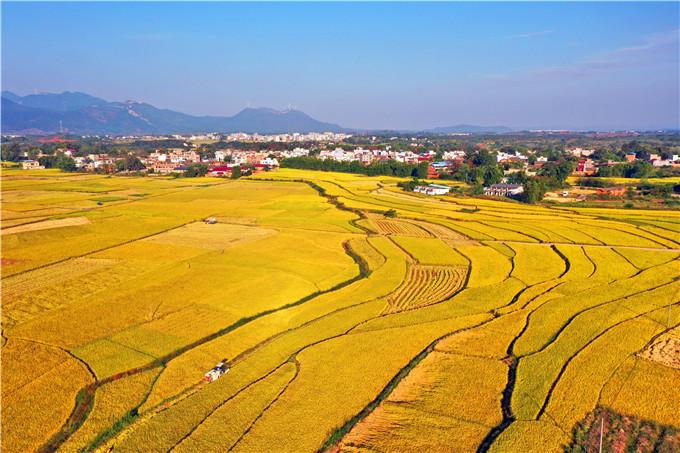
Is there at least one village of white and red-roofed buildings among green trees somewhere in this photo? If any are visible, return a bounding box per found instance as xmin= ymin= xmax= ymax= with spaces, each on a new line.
xmin=9 ymin=132 xmax=680 ymax=203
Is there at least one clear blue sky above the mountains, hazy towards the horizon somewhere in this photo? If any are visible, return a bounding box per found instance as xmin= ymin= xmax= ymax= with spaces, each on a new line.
xmin=2 ymin=2 xmax=680 ymax=129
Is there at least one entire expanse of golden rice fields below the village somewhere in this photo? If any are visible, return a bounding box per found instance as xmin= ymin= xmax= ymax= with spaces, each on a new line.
xmin=1 ymin=169 xmax=680 ymax=453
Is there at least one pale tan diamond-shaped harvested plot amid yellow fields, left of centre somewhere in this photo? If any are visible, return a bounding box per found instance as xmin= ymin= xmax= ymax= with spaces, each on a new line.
xmin=146 ymin=222 xmax=277 ymax=250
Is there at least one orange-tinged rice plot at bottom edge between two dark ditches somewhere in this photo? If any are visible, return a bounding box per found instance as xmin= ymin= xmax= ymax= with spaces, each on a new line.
xmin=340 ymin=352 xmax=507 ymax=451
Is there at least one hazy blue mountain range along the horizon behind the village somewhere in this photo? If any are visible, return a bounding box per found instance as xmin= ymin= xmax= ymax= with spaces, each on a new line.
xmin=1 ymin=91 xmax=511 ymax=135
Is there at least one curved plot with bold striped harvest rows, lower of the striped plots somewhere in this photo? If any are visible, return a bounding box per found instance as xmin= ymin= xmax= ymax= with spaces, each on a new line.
xmin=383 ymin=264 xmax=467 ymax=314
